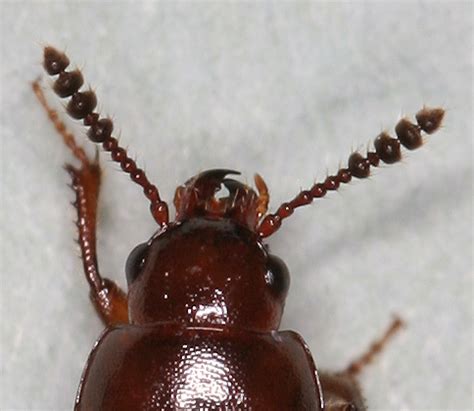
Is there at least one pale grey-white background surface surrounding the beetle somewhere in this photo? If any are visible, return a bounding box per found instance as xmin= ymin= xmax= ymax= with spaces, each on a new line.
xmin=0 ymin=1 xmax=473 ymax=410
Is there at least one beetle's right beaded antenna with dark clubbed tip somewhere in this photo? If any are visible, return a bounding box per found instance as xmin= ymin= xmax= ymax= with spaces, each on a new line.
xmin=257 ymin=107 xmax=444 ymax=238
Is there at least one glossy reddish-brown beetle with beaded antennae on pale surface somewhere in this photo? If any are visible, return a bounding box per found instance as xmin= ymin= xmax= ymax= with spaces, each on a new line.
xmin=33 ymin=46 xmax=444 ymax=411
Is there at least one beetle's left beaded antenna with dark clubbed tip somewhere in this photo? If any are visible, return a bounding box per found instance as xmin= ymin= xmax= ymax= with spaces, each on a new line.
xmin=43 ymin=47 xmax=169 ymax=227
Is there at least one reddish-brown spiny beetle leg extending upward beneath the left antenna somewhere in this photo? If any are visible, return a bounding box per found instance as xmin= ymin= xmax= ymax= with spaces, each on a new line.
xmin=33 ymin=82 xmax=128 ymax=325
